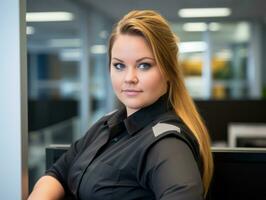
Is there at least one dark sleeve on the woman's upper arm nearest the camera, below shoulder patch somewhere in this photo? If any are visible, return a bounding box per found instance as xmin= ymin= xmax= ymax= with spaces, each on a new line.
xmin=144 ymin=137 xmax=203 ymax=200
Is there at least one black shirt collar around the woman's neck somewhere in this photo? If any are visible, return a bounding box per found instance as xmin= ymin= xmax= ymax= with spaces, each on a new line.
xmin=107 ymin=94 xmax=172 ymax=135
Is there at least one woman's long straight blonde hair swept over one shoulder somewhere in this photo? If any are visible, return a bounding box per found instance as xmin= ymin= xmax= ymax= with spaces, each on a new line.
xmin=108 ymin=10 xmax=213 ymax=195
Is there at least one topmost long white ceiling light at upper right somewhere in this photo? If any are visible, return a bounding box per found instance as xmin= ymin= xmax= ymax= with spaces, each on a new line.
xmin=178 ymin=8 xmax=231 ymax=18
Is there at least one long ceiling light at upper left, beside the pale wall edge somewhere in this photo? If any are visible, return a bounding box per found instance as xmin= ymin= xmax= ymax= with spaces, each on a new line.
xmin=26 ymin=12 xmax=74 ymax=22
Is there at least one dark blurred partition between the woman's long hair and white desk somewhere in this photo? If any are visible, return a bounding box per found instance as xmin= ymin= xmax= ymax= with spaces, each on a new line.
xmin=195 ymin=99 xmax=266 ymax=143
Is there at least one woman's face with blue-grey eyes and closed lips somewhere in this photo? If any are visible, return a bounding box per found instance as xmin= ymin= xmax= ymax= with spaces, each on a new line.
xmin=110 ymin=35 xmax=167 ymax=116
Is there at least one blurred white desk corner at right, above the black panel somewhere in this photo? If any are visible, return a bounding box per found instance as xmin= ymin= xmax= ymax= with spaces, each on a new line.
xmin=228 ymin=123 xmax=266 ymax=148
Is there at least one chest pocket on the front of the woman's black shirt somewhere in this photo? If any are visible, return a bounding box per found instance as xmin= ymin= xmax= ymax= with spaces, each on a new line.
xmin=79 ymin=161 xmax=120 ymax=200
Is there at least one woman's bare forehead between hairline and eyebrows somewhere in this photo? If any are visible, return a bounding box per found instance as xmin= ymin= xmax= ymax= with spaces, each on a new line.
xmin=112 ymin=34 xmax=154 ymax=58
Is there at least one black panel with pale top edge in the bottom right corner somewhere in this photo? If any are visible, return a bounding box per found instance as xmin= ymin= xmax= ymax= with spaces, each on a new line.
xmin=207 ymin=148 xmax=266 ymax=200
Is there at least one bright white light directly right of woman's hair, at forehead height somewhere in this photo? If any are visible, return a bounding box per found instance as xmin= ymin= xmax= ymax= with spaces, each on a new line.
xmin=179 ymin=41 xmax=207 ymax=53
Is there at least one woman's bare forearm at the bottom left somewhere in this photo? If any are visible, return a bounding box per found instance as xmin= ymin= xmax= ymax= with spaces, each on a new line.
xmin=28 ymin=176 xmax=65 ymax=200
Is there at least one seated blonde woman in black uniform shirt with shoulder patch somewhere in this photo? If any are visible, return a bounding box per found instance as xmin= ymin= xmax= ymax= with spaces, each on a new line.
xmin=29 ymin=10 xmax=213 ymax=200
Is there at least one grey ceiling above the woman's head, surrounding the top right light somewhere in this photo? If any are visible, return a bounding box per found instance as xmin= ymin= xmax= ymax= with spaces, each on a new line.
xmin=79 ymin=0 xmax=266 ymax=22
